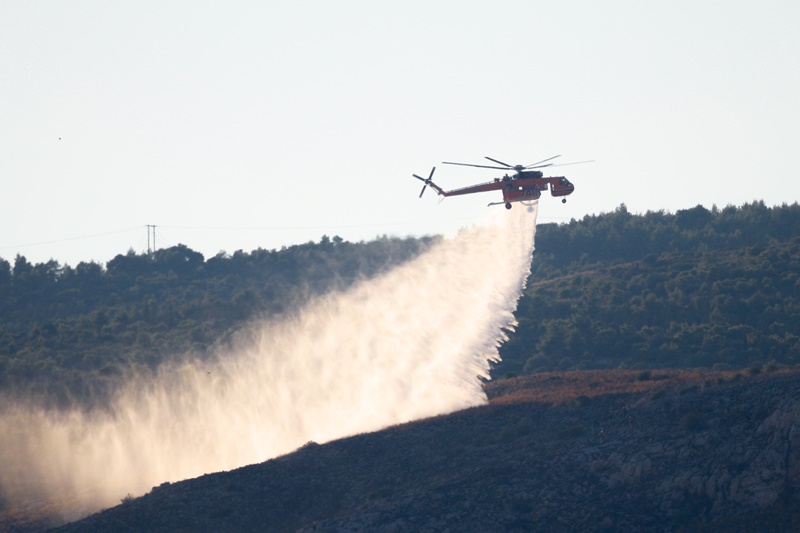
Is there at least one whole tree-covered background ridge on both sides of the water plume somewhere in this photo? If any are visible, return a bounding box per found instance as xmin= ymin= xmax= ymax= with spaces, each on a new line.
xmin=0 ymin=202 xmax=800 ymax=401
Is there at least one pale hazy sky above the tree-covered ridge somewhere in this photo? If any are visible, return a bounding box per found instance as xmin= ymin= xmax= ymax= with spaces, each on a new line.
xmin=0 ymin=0 xmax=800 ymax=266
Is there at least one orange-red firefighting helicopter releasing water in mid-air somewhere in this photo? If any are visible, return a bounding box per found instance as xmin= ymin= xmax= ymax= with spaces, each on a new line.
xmin=412 ymin=155 xmax=590 ymax=209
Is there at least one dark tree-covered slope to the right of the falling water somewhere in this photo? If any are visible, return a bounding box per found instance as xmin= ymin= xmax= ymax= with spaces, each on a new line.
xmin=494 ymin=202 xmax=800 ymax=376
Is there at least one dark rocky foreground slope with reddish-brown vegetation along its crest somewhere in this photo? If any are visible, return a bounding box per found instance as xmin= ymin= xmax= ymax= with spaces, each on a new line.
xmin=40 ymin=371 xmax=800 ymax=532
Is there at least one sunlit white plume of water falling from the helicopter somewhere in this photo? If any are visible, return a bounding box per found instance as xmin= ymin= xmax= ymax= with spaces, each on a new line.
xmin=0 ymin=205 xmax=536 ymax=519
